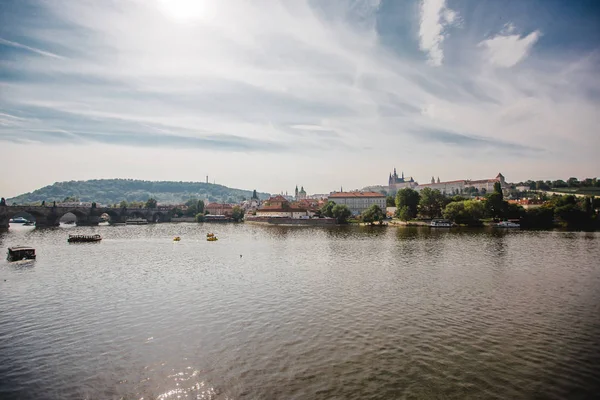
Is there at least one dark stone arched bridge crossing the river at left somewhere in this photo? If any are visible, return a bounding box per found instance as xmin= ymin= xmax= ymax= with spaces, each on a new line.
xmin=0 ymin=205 xmax=171 ymax=229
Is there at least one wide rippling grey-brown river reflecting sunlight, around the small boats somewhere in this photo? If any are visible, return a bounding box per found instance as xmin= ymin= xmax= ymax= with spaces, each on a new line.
xmin=0 ymin=224 xmax=600 ymax=400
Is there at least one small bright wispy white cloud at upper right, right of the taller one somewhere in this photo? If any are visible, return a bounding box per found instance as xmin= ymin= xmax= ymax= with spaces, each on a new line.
xmin=479 ymin=28 xmax=542 ymax=68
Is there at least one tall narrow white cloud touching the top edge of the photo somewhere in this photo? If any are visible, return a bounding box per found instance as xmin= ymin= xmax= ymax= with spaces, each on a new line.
xmin=419 ymin=0 xmax=458 ymax=66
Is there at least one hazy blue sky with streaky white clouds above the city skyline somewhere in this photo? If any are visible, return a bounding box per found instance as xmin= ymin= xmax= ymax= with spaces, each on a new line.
xmin=0 ymin=0 xmax=600 ymax=197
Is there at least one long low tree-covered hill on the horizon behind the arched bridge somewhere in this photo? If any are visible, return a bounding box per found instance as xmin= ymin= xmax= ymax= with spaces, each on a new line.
xmin=7 ymin=179 xmax=269 ymax=204
